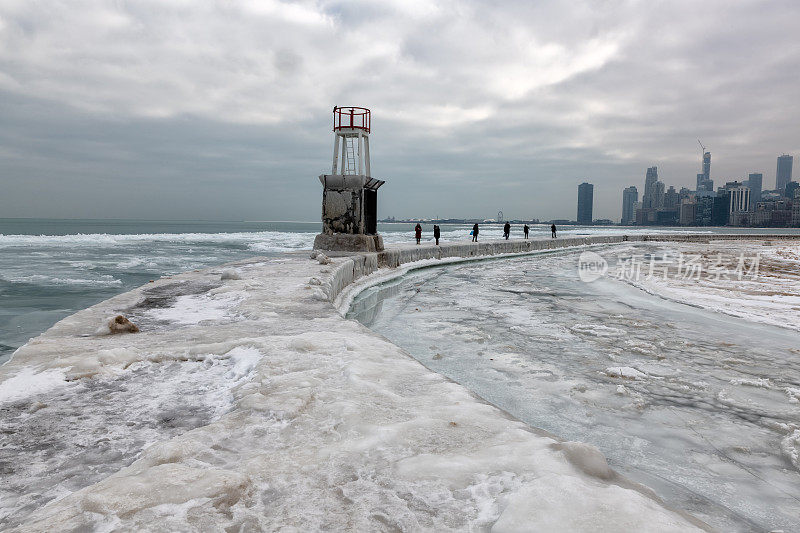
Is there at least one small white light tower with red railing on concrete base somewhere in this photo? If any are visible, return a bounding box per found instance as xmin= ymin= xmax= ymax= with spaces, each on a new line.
xmin=314 ymin=106 xmax=384 ymax=252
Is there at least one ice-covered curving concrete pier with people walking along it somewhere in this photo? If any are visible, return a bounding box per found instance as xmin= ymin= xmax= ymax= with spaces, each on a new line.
xmin=0 ymin=235 xmax=792 ymax=531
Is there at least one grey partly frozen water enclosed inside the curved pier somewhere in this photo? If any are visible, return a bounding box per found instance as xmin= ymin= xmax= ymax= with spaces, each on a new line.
xmin=348 ymin=243 xmax=800 ymax=531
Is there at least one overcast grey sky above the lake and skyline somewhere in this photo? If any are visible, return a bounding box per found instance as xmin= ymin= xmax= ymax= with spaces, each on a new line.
xmin=0 ymin=0 xmax=800 ymax=220
